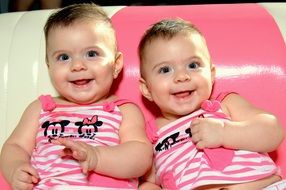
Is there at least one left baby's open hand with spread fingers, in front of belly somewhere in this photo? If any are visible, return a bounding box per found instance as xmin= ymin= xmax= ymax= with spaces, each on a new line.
xmin=53 ymin=138 xmax=98 ymax=174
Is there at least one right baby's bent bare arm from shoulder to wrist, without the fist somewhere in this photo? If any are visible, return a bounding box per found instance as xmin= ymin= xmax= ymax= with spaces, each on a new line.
xmin=222 ymin=94 xmax=284 ymax=152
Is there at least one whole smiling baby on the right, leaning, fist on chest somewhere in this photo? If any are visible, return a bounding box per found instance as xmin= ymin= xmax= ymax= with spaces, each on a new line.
xmin=138 ymin=19 xmax=286 ymax=190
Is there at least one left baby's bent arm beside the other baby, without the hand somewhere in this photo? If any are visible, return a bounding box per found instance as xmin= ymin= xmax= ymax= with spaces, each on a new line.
xmin=96 ymin=104 xmax=153 ymax=178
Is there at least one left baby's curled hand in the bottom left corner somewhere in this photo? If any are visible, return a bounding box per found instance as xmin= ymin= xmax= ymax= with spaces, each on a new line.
xmin=11 ymin=163 xmax=39 ymax=190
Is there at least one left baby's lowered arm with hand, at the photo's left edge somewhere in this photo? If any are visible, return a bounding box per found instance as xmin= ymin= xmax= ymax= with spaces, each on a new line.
xmin=0 ymin=101 xmax=40 ymax=189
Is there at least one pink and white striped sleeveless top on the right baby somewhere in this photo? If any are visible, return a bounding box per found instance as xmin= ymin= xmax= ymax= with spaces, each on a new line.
xmin=146 ymin=93 xmax=278 ymax=190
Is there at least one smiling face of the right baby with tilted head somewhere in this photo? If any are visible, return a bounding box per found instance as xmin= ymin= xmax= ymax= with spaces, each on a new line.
xmin=140 ymin=33 xmax=215 ymax=118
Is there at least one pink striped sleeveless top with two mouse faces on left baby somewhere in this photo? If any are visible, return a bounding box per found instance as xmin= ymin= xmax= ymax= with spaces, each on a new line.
xmin=31 ymin=95 xmax=138 ymax=189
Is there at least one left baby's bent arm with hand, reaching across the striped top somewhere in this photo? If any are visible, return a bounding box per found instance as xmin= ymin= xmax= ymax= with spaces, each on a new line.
xmin=53 ymin=104 xmax=152 ymax=178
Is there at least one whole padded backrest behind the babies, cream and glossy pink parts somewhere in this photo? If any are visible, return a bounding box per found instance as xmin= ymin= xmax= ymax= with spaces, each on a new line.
xmin=0 ymin=3 xmax=286 ymax=189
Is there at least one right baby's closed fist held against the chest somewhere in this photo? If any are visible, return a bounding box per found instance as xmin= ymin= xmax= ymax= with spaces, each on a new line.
xmin=190 ymin=118 xmax=224 ymax=149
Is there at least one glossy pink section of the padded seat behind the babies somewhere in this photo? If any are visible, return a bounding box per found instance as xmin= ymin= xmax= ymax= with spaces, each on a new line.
xmin=0 ymin=3 xmax=286 ymax=190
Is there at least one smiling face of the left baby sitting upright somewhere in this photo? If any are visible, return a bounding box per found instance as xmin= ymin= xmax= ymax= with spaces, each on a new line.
xmin=47 ymin=21 xmax=121 ymax=104
